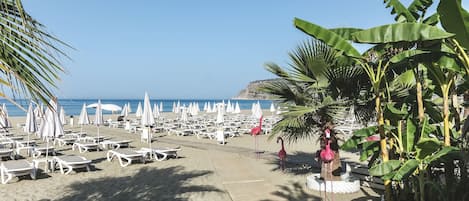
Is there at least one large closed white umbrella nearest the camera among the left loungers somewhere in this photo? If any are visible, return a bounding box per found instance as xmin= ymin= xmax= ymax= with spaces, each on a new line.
xmin=39 ymin=98 xmax=64 ymax=167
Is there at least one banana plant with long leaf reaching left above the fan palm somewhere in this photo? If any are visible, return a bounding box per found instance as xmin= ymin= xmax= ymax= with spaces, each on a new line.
xmin=295 ymin=18 xmax=454 ymax=199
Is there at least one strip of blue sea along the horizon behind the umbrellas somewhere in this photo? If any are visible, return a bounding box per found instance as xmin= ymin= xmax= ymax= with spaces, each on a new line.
xmin=0 ymin=99 xmax=272 ymax=116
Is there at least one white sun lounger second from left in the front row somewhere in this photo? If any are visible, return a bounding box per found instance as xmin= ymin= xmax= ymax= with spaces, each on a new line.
xmin=53 ymin=155 xmax=91 ymax=174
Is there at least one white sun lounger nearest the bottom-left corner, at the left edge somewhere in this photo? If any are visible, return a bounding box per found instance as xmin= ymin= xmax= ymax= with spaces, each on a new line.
xmin=0 ymin=160 xmax=36 ymax=184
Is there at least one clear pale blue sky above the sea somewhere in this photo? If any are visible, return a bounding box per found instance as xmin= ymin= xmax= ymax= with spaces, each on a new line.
xmin=23 ymin=0 xmax=466 ymax=99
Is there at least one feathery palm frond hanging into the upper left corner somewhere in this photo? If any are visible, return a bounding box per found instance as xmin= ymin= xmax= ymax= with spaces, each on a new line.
xmin=0 ymin=0 xmax=70 ymax=108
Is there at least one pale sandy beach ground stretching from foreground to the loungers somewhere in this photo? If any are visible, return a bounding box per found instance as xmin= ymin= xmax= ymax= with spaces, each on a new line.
xmin=0 ymin=115 xmax=380 ymax=201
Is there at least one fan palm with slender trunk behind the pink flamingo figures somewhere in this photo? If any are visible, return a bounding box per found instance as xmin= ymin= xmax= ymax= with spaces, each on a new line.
xmin=261 ymin=40 xmax=369 ymax=179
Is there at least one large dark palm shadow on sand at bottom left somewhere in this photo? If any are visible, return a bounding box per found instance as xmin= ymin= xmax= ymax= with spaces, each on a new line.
xmin=53 ymin=166 xmax=222 ymax=201
